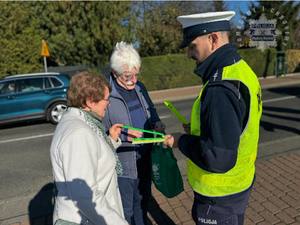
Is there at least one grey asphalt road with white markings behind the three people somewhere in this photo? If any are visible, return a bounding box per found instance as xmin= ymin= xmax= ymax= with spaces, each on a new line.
xmin=0 ymin=85 xmax=300 ymax=219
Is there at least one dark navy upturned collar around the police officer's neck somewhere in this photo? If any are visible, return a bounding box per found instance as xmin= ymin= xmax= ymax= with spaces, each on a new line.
xmin=194 ymin=43 xmax=241 ymax=83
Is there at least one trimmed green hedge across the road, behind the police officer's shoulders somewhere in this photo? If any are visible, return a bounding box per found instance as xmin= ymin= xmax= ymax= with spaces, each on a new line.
xmin=139 ymin=49 xmax=276 ymax=90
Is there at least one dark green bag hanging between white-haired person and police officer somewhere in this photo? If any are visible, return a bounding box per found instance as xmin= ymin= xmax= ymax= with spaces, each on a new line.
xmin=151 ymin=143 xmax=183 ymax=198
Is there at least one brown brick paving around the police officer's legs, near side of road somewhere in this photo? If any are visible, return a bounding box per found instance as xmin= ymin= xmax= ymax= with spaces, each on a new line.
xmin=149 ymin=150 xmax=300 ymax=225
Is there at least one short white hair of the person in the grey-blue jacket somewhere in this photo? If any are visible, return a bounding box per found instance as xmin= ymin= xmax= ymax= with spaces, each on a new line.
xmin=110 ymin=41 xmax=141 ymax=75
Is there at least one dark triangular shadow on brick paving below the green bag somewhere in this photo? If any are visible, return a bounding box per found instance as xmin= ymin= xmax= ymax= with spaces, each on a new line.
xmin=148 ymin=196 xmax=175 ymax=225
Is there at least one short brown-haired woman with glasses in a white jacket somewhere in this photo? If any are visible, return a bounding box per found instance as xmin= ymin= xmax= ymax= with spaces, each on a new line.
xmin=50 ymin=72 xmax=128 ymax=225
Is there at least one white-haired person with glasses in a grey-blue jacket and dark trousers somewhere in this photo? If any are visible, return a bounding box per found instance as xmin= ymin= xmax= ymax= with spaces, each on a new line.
xmin=104 ymin=42 xmax=164 ymax=225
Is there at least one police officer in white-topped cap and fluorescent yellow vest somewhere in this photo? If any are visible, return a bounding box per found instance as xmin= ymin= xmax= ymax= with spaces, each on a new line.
xmin=166 ymin=11 xmax=262 ymax=225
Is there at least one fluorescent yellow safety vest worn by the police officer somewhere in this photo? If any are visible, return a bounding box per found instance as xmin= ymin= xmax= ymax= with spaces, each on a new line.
xmin=187 ymin=60 xmax=262 ymax=197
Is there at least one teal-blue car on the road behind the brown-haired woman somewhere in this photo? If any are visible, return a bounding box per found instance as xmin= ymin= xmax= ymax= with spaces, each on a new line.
xmin=0 ymin=72 xmax=70 ymax=124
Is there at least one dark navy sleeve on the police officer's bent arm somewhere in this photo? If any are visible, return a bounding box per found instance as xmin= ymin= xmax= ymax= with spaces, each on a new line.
xmin=178 ymin=81 xmax=246 ymax=173
